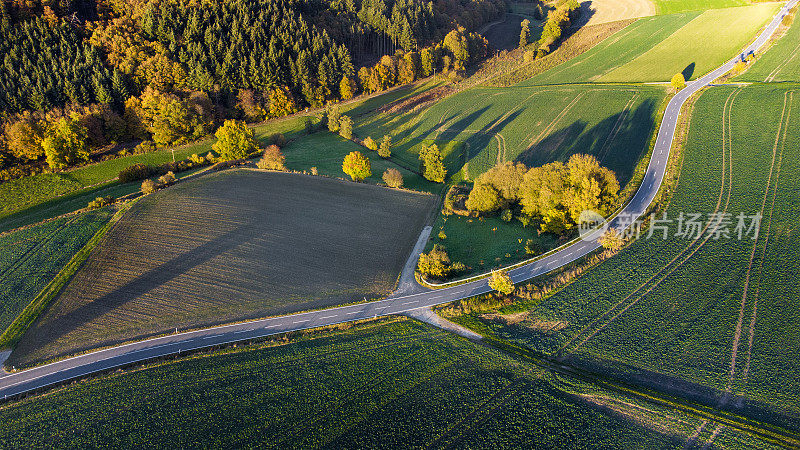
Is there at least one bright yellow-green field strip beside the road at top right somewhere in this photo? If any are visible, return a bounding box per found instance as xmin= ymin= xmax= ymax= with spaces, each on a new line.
xmin=597 ymin=3 xmax=780 ymax=82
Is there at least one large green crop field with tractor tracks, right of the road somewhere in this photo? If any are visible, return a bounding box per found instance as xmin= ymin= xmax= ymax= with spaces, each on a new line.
xmin=466 ymin=85 xmax=800 ymax=429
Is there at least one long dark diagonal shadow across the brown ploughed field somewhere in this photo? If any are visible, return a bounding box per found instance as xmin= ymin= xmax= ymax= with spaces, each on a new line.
xmin=13 ymin=226 xmax=248 ymax=360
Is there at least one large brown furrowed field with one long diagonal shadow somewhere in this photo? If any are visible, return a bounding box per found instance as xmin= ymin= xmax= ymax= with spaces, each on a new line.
xmin=9 ymin=170 xmax=437 ymax=366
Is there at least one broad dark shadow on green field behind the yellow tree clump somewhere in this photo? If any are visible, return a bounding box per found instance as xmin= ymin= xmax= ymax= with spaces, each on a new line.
xmin=516 ymin=99 xmax=656 ymax=186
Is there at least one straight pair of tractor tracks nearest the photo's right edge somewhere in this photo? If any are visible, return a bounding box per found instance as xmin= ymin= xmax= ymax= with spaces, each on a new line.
xmin=725 ymin=91 xmax=794 ymax=400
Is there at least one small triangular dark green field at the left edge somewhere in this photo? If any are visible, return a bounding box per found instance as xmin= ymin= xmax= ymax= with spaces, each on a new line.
xmin=0 ymin=208 xmax=113 ymax=333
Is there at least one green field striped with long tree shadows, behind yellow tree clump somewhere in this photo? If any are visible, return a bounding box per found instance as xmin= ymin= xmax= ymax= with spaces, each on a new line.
xmin=356 ymin=86 xmax=665 ymax=184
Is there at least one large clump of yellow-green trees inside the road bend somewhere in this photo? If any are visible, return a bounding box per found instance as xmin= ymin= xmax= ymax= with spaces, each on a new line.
xmin=466 ymin=154 xmax=619 ymax=234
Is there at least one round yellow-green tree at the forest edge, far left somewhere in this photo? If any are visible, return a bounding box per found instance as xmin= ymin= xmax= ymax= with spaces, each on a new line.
xmin=42 ymin=117 xmax=89 ymax=169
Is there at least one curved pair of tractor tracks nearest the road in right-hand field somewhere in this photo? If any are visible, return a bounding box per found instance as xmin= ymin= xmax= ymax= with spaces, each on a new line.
xmin=555 ymin=88 xmax=742 ymax=355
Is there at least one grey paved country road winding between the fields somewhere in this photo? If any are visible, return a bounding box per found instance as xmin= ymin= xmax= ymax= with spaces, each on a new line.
xmin=0 ymin=0 xmax=799 ymax=399
